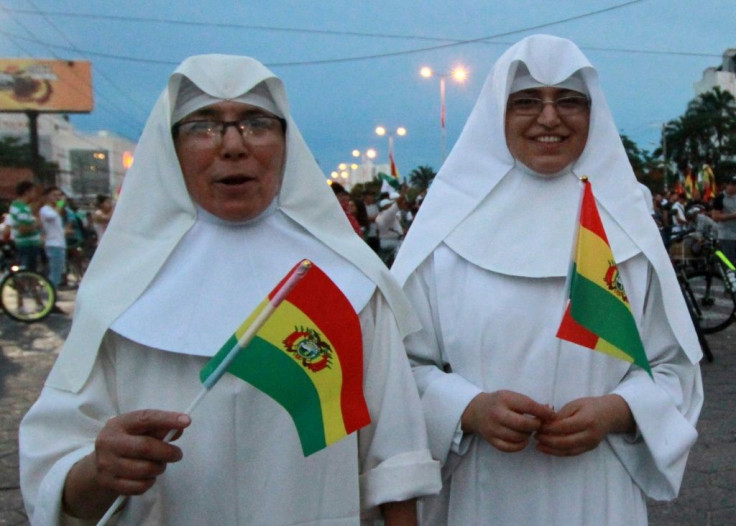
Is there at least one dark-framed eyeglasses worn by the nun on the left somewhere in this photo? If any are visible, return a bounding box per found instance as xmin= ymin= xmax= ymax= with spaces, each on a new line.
xmin=171 ymin=115 xmax=286 ymax=146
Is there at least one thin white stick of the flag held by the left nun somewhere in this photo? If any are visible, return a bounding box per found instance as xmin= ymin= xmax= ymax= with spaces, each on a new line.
xmin=97 ymin=259 xmax=312 ymax=526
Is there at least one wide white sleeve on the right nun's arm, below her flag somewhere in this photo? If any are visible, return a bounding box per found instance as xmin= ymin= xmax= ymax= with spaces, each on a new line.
xmin=608 ymin=262 xmax=703 ymax=500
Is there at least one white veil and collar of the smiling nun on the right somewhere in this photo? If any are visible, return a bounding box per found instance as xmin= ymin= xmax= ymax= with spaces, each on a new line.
xmin=392 ymin=35 xmax=702 ymax=363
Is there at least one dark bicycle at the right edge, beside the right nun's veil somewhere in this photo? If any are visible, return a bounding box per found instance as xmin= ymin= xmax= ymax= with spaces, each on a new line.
xmin=673 ymin=230 xmax=736 ymax=334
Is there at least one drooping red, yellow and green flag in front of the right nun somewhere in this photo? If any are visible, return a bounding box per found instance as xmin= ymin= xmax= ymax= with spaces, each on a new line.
xmin=557 ymin=178 xmax=652 ymax=376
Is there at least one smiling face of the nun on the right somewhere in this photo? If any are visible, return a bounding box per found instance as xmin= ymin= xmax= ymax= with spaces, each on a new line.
xmin=505 ymin=87 xmax=590 ymax=175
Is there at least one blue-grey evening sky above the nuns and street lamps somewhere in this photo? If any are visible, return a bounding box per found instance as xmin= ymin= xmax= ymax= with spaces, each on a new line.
xmin=0 ymin=0 xmax=736 ymax=175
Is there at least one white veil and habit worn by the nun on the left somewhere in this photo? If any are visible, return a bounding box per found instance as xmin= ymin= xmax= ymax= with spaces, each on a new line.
xmin=20 ymin=55 xmax=440 ymax=526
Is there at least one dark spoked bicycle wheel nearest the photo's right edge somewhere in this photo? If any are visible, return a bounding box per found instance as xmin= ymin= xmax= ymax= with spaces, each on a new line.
xmin=687 ymin=272 xmax=736 ymax=334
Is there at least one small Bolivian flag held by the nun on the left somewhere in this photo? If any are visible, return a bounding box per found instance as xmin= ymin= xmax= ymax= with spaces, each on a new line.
xmin=200 ymin=261 xmax=370 ymax=456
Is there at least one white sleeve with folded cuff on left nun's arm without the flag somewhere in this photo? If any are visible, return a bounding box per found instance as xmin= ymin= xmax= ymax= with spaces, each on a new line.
xmin=358 ymin=291 xmax=441 ymax=518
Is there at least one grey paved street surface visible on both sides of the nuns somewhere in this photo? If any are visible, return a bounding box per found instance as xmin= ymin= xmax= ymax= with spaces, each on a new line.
xmin=0 ymin=292 xmax=736 ymax=526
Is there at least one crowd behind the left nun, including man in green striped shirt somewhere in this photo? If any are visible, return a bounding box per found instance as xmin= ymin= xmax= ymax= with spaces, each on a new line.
xmin=0 ymin=181 xmax=113 ymax=300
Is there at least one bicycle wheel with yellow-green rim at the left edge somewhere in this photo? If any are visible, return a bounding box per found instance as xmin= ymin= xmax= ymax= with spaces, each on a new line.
xmin=0 ymin=270 xmax=56 ymax=323
